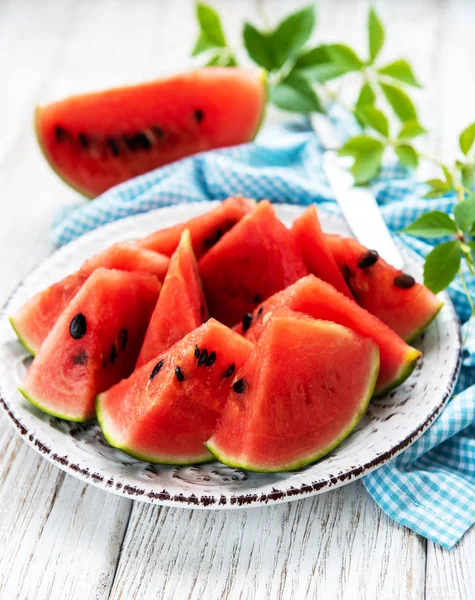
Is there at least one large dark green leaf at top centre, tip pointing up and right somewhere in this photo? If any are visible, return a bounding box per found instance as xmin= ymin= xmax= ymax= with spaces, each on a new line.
xmin=272 ymin=5 xmax=315 ymax=69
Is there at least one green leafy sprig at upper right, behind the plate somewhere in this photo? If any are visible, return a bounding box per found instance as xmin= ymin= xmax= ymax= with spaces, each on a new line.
xmin=193 ymin=2 xmax=475 ymax=314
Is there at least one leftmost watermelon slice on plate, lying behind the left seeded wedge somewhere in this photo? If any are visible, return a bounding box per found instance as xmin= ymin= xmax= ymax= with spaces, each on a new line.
xmin=10 ymin=242 xmax=170 ymax=356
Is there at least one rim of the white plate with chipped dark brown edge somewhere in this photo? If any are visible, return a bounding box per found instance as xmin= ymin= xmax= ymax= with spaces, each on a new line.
xmin=0 ymin=201 xmax=463 ymax=509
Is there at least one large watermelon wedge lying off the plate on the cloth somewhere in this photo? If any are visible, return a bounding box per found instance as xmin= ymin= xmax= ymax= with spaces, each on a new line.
xmin=36 ymin=67 xmax=266 ymax=197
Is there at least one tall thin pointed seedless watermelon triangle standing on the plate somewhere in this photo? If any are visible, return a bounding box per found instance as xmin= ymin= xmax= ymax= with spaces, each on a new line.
xmin=137 ymin=229 xmax=208 ymax=367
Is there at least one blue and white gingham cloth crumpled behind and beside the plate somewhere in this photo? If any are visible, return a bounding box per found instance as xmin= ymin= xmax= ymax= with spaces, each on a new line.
xmin=52 ymin=117 xmax=475 ymax=548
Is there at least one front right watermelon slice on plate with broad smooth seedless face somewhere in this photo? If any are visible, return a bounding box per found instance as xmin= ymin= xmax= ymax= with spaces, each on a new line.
xmin=206 ymin=311 xmax=379 ymax=472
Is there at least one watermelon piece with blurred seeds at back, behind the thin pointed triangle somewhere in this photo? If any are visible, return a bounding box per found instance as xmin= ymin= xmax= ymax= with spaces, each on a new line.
xmin=137 ymin=196 xmax=256 ymax=260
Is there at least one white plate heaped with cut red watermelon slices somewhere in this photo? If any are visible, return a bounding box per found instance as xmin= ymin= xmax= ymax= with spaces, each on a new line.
xmin=0 ymin=196 xmax=461 ymax=509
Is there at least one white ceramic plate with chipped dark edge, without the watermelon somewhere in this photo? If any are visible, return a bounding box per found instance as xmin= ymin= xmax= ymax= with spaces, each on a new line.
xmin=0 ymin=202 xmax=461 ymax=509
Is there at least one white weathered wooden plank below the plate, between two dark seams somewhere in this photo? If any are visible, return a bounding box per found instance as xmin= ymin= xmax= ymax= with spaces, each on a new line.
xmin=111 ymin=482 xmax=425 ymax=600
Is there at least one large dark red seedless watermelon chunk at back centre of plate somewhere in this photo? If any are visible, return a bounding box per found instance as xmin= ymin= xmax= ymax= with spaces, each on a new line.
xmin=199 ymin=200 xmax=308 ymax=325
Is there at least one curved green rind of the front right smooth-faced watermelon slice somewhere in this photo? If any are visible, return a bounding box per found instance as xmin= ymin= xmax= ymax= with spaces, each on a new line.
xmin=204 ymin=348 xmax=379 ymax=473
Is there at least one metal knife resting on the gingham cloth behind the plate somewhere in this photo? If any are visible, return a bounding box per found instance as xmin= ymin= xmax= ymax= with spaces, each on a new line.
xmin=310 ymin=113 xmax=404 ymax=269
